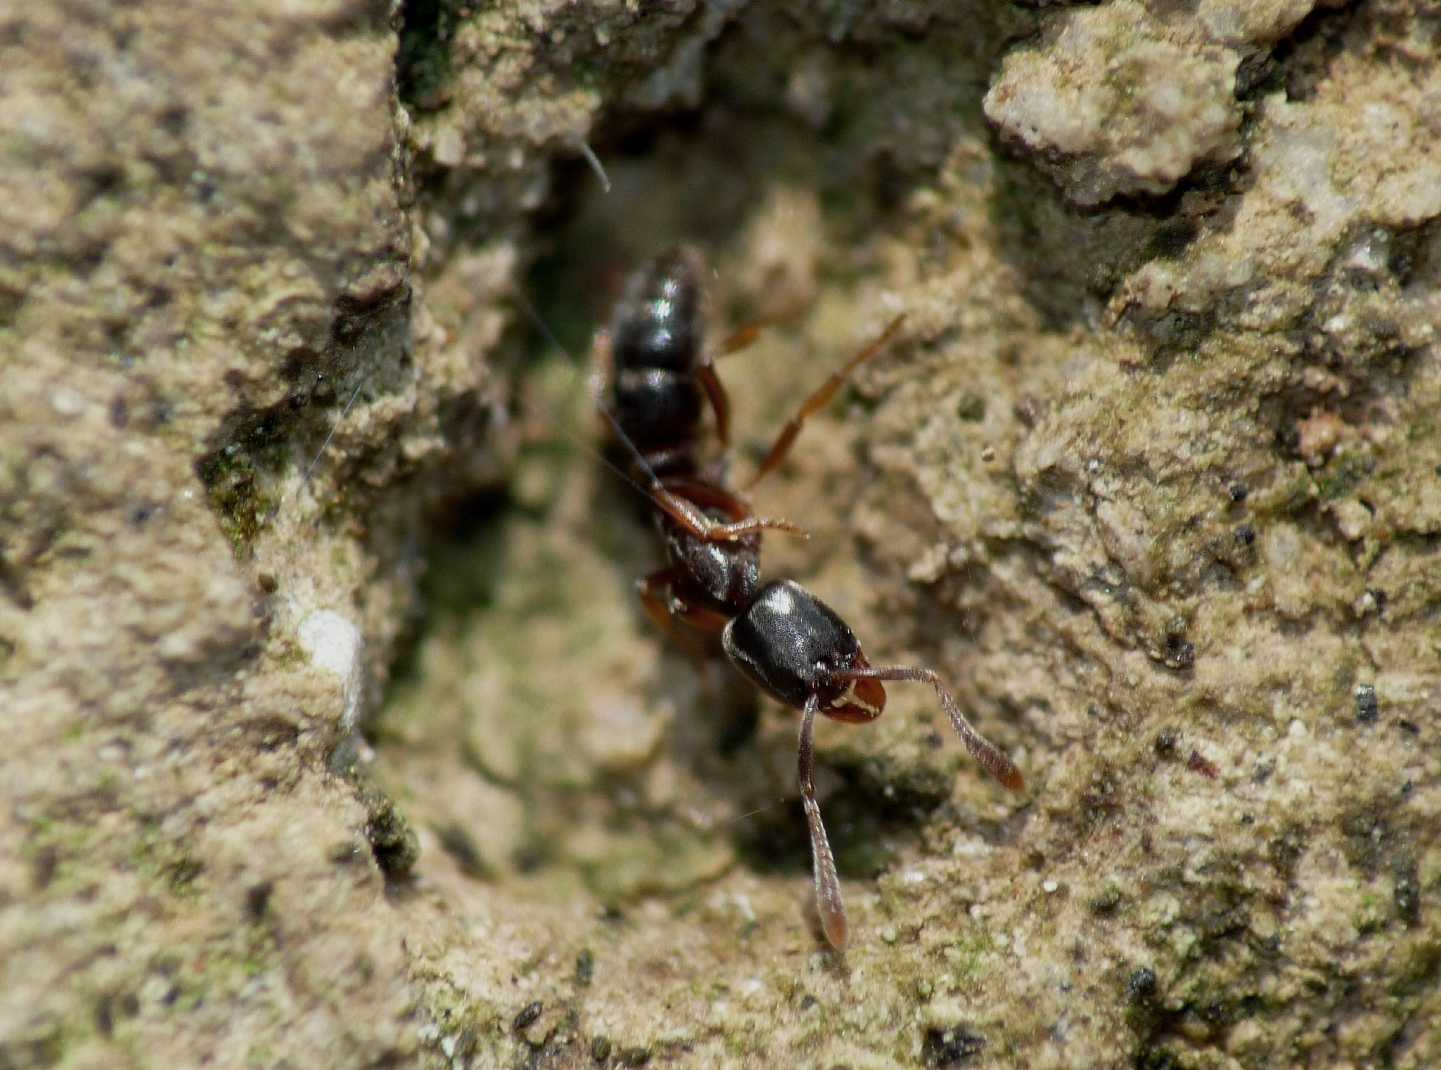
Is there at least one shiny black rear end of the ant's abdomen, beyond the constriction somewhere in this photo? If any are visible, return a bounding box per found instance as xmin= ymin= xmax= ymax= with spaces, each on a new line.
xmin=611 ymin=249 xmax=702 ymax=373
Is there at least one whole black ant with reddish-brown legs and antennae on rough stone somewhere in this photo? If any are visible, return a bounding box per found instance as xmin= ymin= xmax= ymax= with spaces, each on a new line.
xmin=597 ymin=249 xmax=1023 ymax=952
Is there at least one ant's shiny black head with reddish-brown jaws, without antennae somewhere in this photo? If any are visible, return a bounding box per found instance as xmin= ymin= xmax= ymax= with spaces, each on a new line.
xmin=721 ymin=579 xmax=886 ymax=721
